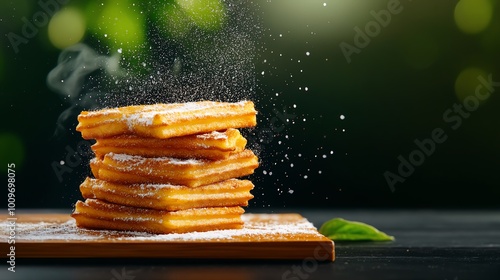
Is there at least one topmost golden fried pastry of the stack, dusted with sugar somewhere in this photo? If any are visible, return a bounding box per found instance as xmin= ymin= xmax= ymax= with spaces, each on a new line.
xmin=76 ymin=101 xmax=257 ymax=139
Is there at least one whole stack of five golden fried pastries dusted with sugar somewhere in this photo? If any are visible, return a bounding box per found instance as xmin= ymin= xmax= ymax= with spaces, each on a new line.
xmin=72 ymin=101 xmax=258 ymax=233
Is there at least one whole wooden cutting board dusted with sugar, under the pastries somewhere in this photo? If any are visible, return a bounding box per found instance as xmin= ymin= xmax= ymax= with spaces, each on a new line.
xmin=0 ymin=214 xmax=335 ymax=261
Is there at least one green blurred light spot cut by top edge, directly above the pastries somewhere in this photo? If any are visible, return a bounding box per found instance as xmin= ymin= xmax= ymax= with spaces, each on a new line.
xmin=177 ymin=0 xmax=226 ymax=30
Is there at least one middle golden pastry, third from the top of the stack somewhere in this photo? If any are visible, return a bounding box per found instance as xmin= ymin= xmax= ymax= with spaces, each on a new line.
xmin=90 ymin=150 xmax=259 ymax=187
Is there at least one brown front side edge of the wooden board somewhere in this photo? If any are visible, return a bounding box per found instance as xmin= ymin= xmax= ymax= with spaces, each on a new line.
xmin=0 ymin=241 xmax=335 ymax=261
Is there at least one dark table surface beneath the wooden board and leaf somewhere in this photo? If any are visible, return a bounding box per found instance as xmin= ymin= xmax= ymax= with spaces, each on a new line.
xmin=0 ymin=209 xmax=500 ymax=280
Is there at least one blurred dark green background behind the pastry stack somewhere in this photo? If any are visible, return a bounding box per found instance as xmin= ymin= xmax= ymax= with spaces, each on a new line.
xmin=0 ymin=0 xmax=500 ymax=208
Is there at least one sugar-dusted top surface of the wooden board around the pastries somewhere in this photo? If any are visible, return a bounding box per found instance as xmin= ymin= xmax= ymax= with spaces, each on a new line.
xmin=0 ymin=214 xmax=321 ymax=242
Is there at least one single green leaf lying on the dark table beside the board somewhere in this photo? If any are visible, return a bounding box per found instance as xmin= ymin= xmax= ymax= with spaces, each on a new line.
xmin=319 ymin=218 xmax=394 ymax=241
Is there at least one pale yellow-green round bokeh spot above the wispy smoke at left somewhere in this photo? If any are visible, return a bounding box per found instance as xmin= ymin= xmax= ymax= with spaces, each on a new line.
xmin=49 ymin=8 xmax=86 ymax=49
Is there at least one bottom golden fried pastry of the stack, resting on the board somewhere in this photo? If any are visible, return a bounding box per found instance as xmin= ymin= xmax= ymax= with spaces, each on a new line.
xmin=71 ymin=199 xmax=244 ymax=233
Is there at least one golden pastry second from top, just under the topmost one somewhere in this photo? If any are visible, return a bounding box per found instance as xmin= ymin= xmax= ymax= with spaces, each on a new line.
xmin=92 ymin=128 xmax=247 ymax=160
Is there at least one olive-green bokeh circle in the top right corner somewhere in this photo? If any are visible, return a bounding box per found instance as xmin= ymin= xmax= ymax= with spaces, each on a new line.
xmin=454 ymin=0 xmax=493 ymax=34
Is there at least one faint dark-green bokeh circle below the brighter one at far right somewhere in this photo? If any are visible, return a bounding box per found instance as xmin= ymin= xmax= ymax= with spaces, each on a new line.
xmin=455 ymin=67 xmax=488 ymax=104
